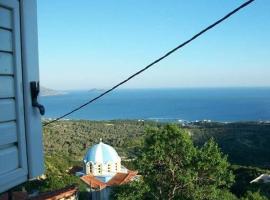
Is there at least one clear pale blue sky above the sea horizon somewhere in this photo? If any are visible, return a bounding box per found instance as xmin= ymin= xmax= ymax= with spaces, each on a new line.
xmin=37 ymin=0 xmax=270 ymax=90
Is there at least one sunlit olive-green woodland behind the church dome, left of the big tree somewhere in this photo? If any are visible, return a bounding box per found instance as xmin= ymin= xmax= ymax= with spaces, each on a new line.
xmin=44 ymin=121 xmax=152 ymax=160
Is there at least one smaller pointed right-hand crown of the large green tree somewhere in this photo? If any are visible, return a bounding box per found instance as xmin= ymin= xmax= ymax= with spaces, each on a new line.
xmin=194 ymin=139 xmax=234 ymax=199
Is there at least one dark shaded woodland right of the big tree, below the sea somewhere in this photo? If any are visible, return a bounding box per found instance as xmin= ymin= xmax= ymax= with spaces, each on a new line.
xmin=188 ymin=122 xmax=270 ymax=168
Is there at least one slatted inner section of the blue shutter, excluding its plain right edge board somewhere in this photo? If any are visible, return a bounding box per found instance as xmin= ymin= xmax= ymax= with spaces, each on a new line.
xmin=0 ymin=0 xmax=28 ymax=192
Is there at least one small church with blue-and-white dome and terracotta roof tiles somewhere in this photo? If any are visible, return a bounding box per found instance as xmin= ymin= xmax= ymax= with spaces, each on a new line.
xmin=81 ymin=139 xmax=138 ymax=200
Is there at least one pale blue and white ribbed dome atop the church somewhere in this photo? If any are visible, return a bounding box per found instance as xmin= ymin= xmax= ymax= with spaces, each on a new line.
xmin=83 ymin=141 xmax=121 ymax=163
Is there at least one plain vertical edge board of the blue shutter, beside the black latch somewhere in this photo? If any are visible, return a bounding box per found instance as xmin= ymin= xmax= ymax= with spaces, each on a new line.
xmin=19 ymin=0 xmax=44 ymax=179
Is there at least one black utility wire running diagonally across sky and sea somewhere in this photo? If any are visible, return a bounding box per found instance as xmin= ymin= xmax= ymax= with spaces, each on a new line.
xmin=43 ymin=0 xmax=254 ymax=126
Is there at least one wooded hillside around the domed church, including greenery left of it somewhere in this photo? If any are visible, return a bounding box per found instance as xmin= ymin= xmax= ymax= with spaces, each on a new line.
xmin=15 ymin=121 xmax=270 ymax=200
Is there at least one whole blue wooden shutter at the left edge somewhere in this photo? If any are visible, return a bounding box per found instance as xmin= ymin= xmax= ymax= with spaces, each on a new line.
xmin=0 ymin=0 xmax=43 ymax=193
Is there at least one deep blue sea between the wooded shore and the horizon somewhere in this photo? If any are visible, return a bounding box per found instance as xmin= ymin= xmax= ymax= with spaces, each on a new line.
xmin=41 ymin=88 xmax=270 ymax=122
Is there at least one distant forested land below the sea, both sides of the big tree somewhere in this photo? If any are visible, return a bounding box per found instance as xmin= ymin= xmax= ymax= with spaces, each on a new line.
xmin=44 ymin=121 xmax=270 ymax=168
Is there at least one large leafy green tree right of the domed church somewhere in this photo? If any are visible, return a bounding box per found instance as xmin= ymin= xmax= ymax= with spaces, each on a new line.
xmin=112 ymin=125 xmax=234 ymax=200
